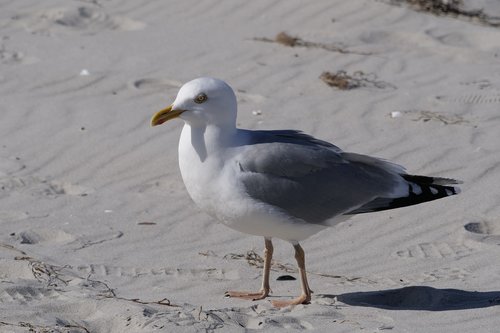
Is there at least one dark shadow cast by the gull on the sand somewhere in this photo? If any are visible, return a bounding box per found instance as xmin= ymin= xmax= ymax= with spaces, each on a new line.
xmin=323 ymin=286 xmax=500 ymax=311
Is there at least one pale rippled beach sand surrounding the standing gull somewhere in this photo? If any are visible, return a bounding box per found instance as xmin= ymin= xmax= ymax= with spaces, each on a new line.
xmin=0 ymin=0 xmax=500 ymax=332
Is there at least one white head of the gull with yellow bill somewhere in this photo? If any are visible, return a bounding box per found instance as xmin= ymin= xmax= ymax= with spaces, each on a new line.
xmin=151 ymin=77 xmax=237 ymax=127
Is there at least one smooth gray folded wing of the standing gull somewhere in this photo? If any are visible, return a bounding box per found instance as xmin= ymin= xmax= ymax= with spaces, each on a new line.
xmin=237 ymin=131 xmax=404 ymax=224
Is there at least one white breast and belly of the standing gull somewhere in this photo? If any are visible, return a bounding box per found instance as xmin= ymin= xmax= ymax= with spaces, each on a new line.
xmin=179 ymin=125 xmax=325 ymax=241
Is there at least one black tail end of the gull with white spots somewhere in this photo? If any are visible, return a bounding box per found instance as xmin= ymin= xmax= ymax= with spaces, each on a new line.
xmin=347 ymin=174 xmax=462 ymax=214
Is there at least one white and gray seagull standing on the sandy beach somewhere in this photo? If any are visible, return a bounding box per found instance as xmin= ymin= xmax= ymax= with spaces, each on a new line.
xmin=151 ymin=77 xmax=460 ymax=307
